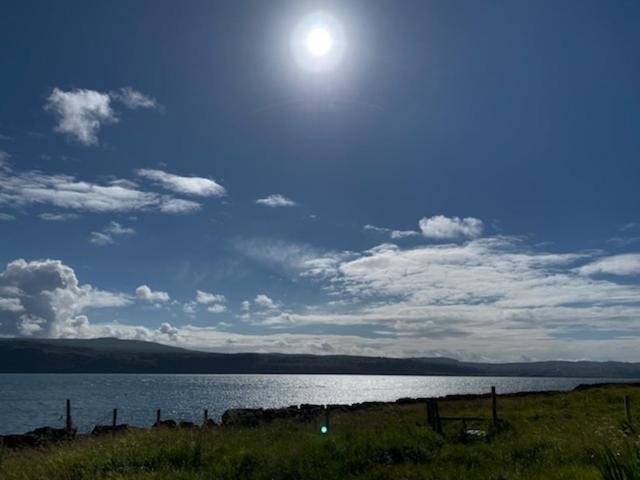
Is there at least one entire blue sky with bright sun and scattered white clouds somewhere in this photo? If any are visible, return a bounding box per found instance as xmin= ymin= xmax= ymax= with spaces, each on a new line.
xmin=0 ymin=0 xmax=640 ymax=361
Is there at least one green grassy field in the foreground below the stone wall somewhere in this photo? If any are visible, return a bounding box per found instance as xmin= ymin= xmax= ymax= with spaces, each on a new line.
xmin=0 ymin=387 xmax=640 ymax=480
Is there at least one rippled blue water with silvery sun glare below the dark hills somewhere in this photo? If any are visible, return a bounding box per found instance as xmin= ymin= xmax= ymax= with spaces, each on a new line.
xmin=0 ymin=374 xmax=632 ymax=434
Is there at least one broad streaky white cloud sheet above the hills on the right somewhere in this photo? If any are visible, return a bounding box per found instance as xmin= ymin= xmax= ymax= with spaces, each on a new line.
xmin=231 ymin=231 xmax=640 ymax=359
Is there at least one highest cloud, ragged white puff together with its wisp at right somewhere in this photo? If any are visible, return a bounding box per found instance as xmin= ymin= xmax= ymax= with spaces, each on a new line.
xmin=44 ymin=87 xmax=159 ymax=146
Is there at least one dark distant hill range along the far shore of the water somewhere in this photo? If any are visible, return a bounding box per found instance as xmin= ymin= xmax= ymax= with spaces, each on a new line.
xmin=0 ymin=338 xmax=640 ymax=379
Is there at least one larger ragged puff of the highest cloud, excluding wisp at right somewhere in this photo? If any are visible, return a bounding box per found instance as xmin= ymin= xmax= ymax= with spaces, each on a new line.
xmin=45 ymin=88 xmax=118 ymax=145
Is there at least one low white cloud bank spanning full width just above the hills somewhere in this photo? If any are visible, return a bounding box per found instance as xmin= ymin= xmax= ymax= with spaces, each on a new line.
xmin=0 ymin=244 xmax=640 ymax=360
